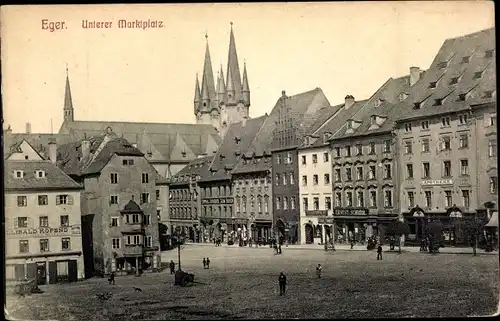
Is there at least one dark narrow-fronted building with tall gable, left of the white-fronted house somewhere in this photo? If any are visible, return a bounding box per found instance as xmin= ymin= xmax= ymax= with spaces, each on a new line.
xmin=271 ymin=88 xmax=330 ymax=243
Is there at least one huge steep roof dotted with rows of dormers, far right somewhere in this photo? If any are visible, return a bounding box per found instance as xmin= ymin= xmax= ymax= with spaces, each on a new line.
xmin=391 ymin=28 xmax=496 ymax=121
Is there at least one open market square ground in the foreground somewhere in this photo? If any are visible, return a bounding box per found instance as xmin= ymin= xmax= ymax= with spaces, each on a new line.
xmin=7 ymin=244 xmax=499 ymax=320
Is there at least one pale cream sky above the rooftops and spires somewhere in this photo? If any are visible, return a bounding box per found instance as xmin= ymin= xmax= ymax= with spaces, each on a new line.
xmin=0 ymin=1 xmax=494 ymax=133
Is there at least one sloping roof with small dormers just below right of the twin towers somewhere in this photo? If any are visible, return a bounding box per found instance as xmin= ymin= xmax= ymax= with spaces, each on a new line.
xmin=201 ymin=115 xmax=269 ymax=181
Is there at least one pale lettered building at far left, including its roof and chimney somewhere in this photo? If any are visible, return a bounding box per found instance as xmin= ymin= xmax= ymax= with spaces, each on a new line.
xmin=4 ymin=140 xmax=84 ymax=284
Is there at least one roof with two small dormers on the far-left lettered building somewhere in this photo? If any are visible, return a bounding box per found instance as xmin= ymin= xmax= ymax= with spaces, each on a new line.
xmin=4 ymin=160 xmax=83 ymax=191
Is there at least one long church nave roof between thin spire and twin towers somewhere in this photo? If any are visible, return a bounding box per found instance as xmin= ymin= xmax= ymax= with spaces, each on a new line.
xmin=59 ymin=121 xmax=221 ymax=162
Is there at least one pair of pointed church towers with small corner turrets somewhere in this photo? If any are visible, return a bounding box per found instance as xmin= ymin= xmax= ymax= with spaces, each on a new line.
xmin=194 ymin=23 xmax=250 ymax=128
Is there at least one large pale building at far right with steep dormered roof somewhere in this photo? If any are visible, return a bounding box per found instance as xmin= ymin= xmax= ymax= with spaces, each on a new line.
xmin=396 ymin=29 xmax=497 ymax=244
